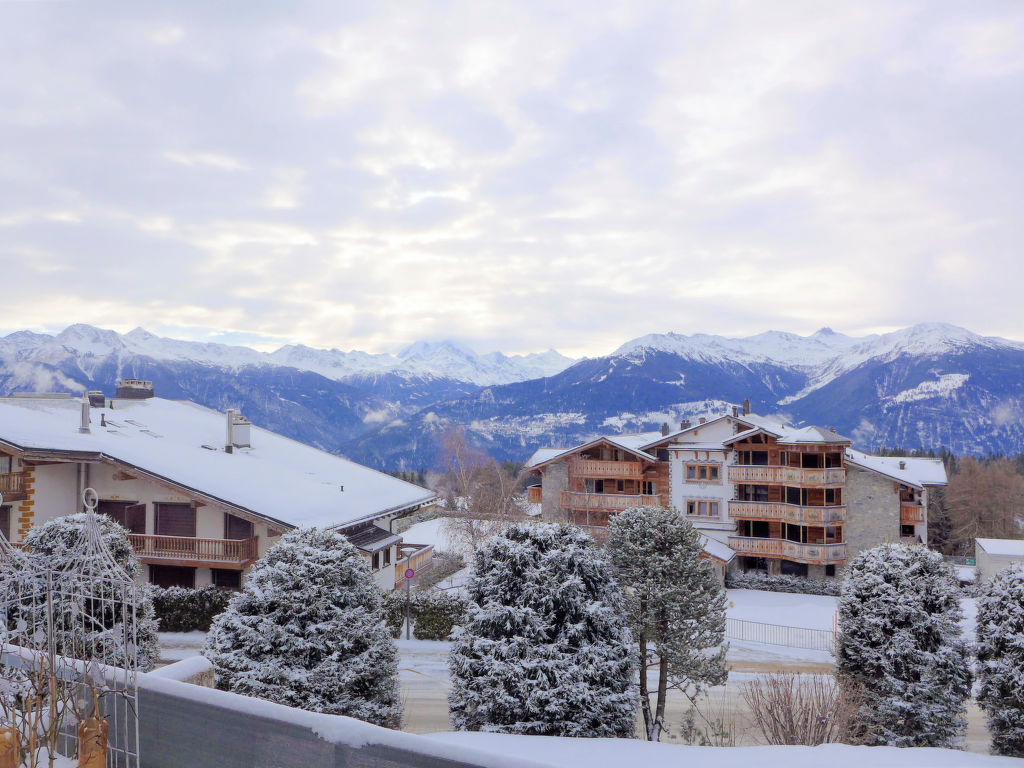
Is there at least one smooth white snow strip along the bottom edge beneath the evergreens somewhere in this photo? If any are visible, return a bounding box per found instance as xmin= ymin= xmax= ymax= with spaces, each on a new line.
xmin=427 ymin=732 xmax=1021 ymax=768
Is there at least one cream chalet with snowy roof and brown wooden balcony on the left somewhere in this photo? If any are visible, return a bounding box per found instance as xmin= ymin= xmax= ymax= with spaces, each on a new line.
xmin=0 ymin=382 xmax=434 ymax=589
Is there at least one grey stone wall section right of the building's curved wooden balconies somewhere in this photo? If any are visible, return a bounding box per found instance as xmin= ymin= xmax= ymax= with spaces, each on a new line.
xmin=837 ymin=464 xmax=900 ymax=571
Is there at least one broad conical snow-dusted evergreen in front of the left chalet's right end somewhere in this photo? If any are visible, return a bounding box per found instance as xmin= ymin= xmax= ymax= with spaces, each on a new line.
xmin=205 ymin=528 xmax=401 ymax=728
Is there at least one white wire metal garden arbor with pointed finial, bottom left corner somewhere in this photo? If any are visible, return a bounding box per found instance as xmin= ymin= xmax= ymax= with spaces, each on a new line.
xmin=0 ymin=488 xmax=142 ymax=768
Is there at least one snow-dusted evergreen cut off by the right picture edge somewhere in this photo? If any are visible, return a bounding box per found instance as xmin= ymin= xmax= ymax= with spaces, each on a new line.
xmin=977 ymin=564 xmax=1024 ymax=758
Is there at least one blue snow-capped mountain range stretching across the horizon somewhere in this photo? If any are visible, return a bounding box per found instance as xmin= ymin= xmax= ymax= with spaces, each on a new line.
xmin=0 ymin=324 xmax=1024 ymax=469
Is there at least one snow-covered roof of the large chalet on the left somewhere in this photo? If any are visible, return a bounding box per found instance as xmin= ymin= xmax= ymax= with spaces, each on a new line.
xmin=0 ymin=397 xmax=434 ymax=527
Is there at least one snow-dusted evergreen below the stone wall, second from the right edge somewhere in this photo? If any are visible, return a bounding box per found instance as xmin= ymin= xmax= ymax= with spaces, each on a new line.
xmin=836 ymin=544 xmax=971 ymax=748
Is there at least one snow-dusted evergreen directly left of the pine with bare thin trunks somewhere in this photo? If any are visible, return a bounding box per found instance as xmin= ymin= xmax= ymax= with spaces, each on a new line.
xmin=449 ymin=524 xmax=636 ymax=736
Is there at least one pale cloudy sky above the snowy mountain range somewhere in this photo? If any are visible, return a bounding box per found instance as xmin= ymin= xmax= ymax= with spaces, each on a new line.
xmin=0 ymin=0 xmax=1024 ymax=356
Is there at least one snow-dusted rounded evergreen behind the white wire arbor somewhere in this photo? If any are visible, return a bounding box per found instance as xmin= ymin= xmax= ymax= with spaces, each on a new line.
xmin=25 ymin=514 xmax=160 ymax=672
